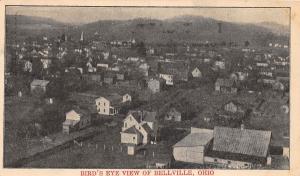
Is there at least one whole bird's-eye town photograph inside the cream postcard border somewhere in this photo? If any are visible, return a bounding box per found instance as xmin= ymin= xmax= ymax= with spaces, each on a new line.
xmin=3 ymin=5 xmax=291 ymax=170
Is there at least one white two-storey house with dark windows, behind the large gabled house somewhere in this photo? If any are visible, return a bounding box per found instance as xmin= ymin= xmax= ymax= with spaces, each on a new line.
xmin=95 ymin=93 xmax=131 ymax=115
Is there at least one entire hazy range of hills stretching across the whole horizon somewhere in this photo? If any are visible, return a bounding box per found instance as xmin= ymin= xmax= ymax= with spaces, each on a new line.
xmin=6 ymin=16 xmax=289 ymax=46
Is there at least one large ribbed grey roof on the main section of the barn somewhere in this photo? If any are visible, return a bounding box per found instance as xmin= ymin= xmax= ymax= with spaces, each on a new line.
xmin=213 ymin=127 xmax=271 ymax=157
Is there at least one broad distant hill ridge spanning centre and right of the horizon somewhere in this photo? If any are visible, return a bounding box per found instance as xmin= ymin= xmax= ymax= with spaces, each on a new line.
xmin=78 ymin=16 xmax=289 ymax=45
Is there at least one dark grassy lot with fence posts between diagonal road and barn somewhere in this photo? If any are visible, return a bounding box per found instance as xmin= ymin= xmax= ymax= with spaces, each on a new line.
xmin=25 ymin=120 xmax=176 ymax=168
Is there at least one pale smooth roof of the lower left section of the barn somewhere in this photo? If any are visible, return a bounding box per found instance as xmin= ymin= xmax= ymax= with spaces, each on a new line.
xmin=173 ymin=130 xmax=213 ymax=147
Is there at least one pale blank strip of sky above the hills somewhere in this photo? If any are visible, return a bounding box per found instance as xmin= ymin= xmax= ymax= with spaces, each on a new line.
xmin=6 ymin=6 xmax=290 ymax=25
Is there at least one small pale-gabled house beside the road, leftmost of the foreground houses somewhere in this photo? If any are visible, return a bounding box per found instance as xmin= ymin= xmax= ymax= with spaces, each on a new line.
xmin=63 ymin=108 xmax=91 ymax=134
